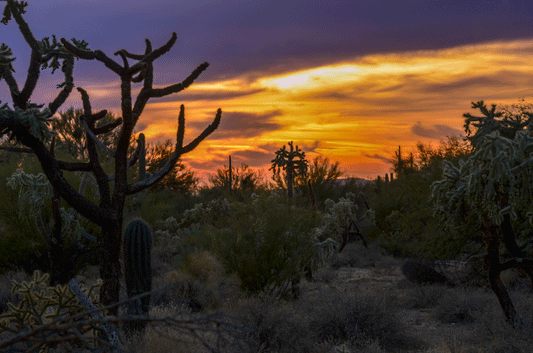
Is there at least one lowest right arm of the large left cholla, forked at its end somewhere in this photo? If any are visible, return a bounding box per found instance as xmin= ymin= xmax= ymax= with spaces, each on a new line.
xmin=127 ymin=105 xmax=222 ymax=195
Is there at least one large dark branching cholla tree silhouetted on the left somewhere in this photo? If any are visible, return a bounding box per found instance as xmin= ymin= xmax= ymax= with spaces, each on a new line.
xmin=0 ymin=0 xmax=222 ymax=314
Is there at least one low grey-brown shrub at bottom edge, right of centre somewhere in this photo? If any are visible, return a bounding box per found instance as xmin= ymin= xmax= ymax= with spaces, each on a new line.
xmin=308 ymin=293 xmax=421 ymax=351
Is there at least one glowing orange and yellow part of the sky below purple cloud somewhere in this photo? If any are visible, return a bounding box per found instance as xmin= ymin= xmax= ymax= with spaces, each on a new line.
xmin=77 ymin=40 xmax=533 ymax=182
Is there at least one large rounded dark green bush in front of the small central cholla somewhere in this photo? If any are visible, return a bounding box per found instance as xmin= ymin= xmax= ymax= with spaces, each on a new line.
xmin=208 ymin=197 xmax=319 ymax=293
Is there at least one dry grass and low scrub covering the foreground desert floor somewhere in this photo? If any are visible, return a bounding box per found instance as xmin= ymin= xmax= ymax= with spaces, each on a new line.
xmin=0 ymin=244 xmax=533 ymax=353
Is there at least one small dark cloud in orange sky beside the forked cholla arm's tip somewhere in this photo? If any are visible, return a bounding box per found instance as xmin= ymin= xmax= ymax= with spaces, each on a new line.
xmin=191 ymin=110 xmax=282 ymax=140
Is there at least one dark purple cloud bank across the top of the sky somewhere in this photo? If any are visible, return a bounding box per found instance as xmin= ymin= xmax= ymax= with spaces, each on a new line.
xmin=7 ymin=0 xmax=533 ymax=81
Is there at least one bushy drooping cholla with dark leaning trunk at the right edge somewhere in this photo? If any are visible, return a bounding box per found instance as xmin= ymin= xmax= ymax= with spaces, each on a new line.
xmin=432 ymin=102 xmax=533 ymax=326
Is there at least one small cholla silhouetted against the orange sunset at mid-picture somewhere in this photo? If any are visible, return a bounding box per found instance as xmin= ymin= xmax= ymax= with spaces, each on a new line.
xmin=269 ymin=141 xmax=307 ymax=201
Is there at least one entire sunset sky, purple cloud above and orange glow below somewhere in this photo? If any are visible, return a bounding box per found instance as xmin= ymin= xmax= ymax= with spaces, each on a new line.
xmin=0 ymin=0 xmax=533 ymax=182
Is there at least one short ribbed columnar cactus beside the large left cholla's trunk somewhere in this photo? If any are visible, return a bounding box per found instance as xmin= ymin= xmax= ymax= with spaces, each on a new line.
xmin=124 ymin=218 xmax=152 ymax=332
